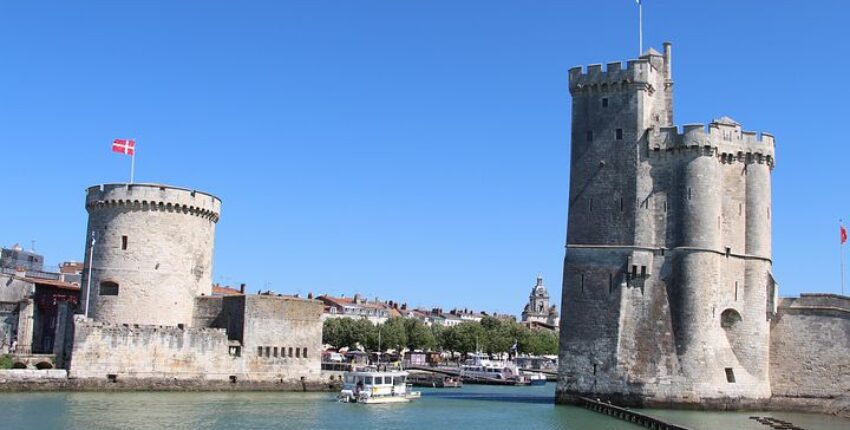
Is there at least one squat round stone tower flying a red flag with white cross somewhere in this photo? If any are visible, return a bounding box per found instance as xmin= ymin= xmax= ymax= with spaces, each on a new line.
xmin=81 ymin=184 xmax=221 ymax=326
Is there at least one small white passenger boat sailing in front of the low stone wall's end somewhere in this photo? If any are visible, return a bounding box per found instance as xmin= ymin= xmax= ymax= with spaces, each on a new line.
xmin=339 ymin=370 xmax=421 ymax=404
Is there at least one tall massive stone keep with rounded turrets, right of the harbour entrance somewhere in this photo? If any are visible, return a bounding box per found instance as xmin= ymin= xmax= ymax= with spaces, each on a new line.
xmin=558 ymin=43 xmax=775 ymax=405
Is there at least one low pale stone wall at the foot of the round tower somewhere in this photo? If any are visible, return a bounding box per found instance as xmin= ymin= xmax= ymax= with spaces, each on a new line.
xmin=69 ymin=295 xmax=323 ymax=383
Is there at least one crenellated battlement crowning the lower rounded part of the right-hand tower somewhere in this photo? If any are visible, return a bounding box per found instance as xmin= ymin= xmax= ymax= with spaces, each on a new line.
xmin=648 ymin=121 xmax=776 ymax=169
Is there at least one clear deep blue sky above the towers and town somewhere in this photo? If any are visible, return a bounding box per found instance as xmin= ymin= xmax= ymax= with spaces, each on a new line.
xmin=0 ymin=0 xmax=850 ymax=313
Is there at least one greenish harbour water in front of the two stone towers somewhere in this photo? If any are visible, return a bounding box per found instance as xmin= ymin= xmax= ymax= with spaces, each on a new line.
xmin=0 ymin=383 xmax=850 ymax=430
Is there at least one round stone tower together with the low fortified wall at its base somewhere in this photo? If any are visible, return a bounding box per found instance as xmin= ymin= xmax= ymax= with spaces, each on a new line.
xmin=68 ymin=184 xmax=324 ymax=384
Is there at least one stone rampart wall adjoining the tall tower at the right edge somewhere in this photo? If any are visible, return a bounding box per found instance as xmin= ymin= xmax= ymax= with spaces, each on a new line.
xmin=770 ymin=294 xmax=850 ymax=399
